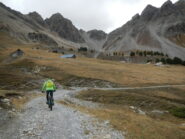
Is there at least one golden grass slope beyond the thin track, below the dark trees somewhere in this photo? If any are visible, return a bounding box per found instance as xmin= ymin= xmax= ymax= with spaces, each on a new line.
xmin=0 ymin=32 xmax=185 ymax=86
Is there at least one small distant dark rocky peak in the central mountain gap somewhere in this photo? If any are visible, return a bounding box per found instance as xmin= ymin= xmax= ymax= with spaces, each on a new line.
xmin=87 ymin=30 xmax=107 ymax=40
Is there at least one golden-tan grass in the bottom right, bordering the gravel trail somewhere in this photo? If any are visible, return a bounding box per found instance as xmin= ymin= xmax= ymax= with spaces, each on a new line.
xmin=60 ymin=98 xmax=185 ymax=139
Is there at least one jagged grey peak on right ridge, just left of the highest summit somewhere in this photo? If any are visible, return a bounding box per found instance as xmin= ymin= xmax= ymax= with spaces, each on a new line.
xmin=141 ymin=5 xmax=158 ymax=20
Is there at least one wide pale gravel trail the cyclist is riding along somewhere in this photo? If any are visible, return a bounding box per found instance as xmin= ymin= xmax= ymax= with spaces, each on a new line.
xmin=0 ymin=90 xmax=124 ymax=139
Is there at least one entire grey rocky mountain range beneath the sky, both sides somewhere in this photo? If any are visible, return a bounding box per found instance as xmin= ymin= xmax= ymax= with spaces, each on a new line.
xmin=0 ymin=0 xmax=185 ymax=59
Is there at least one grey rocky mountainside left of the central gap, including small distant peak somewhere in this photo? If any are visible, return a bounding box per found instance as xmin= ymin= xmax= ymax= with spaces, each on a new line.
xmin=0 ymin=3 xmax=106 ymax=51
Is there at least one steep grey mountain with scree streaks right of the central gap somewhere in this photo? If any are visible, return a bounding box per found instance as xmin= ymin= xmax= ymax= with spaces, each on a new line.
xmin=103 ymin=0 xmax=185 ymax=60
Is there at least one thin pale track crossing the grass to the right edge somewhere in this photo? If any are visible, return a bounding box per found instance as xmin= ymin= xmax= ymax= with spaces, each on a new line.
xmin=94 ymin=85 xmax=185 ymax=90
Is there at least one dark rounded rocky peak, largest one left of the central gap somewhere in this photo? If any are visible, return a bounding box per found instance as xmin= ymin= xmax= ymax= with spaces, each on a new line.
xmin=45 ymin=13 xmax=85 ymax=43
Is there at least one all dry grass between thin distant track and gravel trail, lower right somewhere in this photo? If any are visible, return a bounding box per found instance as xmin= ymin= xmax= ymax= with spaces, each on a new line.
xmin=73 ymin=87 xmax=185 ymax=139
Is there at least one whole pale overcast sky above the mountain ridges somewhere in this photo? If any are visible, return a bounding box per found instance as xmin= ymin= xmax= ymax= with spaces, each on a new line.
xmin=0 ymin=0 xmax=177 ymax=32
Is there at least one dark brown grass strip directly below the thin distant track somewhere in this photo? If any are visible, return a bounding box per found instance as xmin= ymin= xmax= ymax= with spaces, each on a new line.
xmin=77 ymin=88 xmax=185 ymax=110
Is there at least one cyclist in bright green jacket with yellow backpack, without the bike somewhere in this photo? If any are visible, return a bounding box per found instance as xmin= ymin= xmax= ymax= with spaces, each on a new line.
xmin=42 ymin=79 xmax=56 ymax=105
